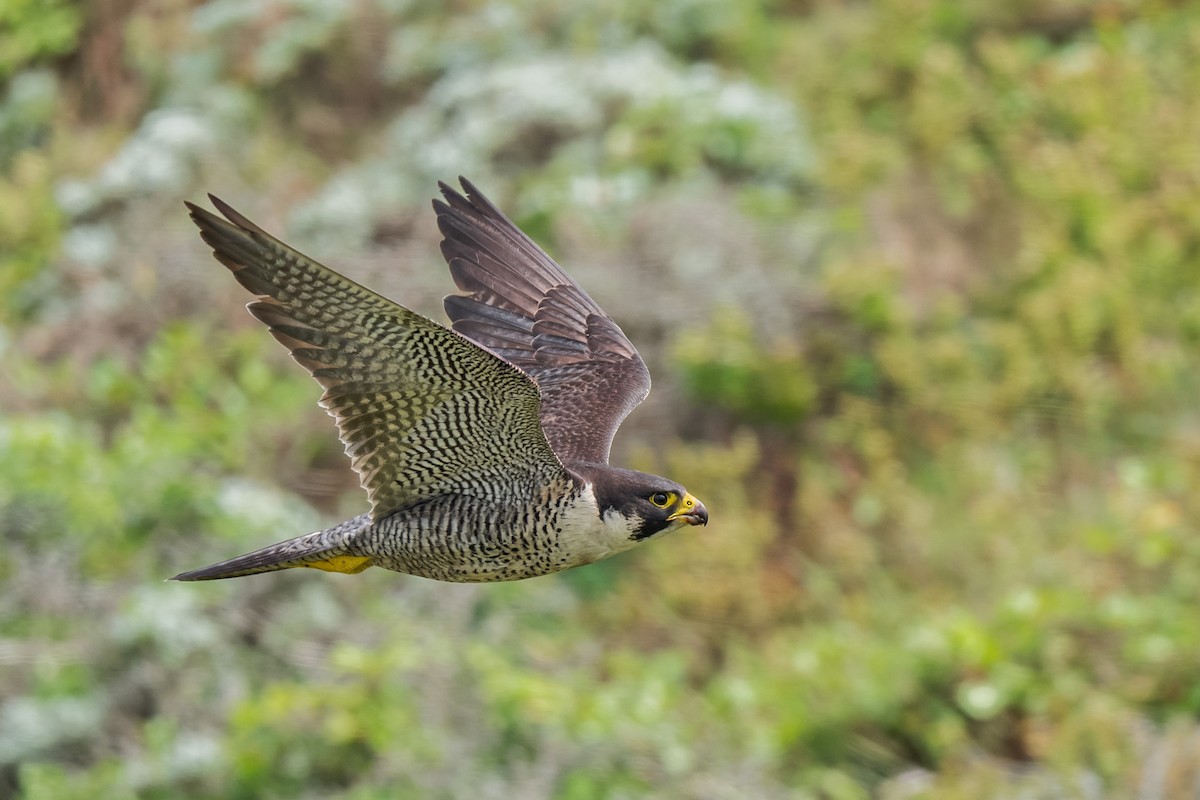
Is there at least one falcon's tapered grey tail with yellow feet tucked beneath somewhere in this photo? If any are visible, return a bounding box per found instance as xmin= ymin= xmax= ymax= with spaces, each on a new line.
xmin=172 ymin=515 xmax=372 ymax=581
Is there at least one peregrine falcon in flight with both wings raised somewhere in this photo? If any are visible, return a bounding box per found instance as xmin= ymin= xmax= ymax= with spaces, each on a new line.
xmin=173 ymin=178 xmax=708 ymax=582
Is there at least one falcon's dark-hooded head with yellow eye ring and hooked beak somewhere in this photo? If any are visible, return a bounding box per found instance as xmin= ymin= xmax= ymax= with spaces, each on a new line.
xmin=584 ymin=465 xmax=708 ymax=542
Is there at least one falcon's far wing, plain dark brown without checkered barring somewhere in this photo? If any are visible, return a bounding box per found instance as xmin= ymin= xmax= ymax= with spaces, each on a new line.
xmin=433 ymin=178 xmax=650 ymax=464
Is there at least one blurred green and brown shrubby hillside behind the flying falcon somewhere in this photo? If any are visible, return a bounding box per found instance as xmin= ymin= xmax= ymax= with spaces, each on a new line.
xmin=0 ymin=0 xmax=1200 ymax=800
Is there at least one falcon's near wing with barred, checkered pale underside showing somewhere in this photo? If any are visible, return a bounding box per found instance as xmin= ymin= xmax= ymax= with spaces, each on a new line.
xmin=187 ymin=196 xmax=563 ymax=521
